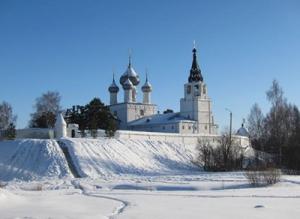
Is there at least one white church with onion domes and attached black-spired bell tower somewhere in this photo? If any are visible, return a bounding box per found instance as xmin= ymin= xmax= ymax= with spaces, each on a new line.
xmin=108 ymin=48 xmax=218 ymax=135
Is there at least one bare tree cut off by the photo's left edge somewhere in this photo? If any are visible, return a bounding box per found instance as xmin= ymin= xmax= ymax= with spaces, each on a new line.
xmin=0 ymin=101 xmax=17 ymax=130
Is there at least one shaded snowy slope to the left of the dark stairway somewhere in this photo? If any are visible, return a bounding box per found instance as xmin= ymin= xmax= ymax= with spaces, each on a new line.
xmin=0 ymin=139 xmax=70 ymax=181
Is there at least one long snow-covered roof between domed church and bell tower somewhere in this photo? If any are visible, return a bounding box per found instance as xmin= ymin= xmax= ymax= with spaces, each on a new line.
xmin=128 ymin=113 xmax=194 ymax=126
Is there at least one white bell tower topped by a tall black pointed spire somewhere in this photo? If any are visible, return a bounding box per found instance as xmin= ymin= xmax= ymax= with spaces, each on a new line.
xmin=180 ymin=46 xmax=217 ymax=134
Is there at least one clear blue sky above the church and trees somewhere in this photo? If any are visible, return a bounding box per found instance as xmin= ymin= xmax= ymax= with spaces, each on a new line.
xmin=0 ymin=0 xmax=300 ymax=130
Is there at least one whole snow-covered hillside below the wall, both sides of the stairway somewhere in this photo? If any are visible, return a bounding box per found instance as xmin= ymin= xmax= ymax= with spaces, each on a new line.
xmin=0 ymin=138 xmax=196 ymax=181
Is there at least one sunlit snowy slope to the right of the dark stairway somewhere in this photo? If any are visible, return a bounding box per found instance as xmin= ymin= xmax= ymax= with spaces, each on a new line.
xmin=62 ymin=139 xmax=196 ymax=178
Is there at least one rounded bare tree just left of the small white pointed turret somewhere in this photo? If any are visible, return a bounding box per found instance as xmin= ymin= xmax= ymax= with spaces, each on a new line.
xmin=29 ymin=91 xmax=61 ymax=128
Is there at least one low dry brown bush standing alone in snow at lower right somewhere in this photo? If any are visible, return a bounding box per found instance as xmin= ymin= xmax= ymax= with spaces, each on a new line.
xmin=245 ymin=167 xmax=281 ymax=186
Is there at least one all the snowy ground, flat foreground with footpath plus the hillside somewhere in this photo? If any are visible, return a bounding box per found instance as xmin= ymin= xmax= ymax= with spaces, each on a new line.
xmin=0 ymin=139 xmax=300 ymax=219
